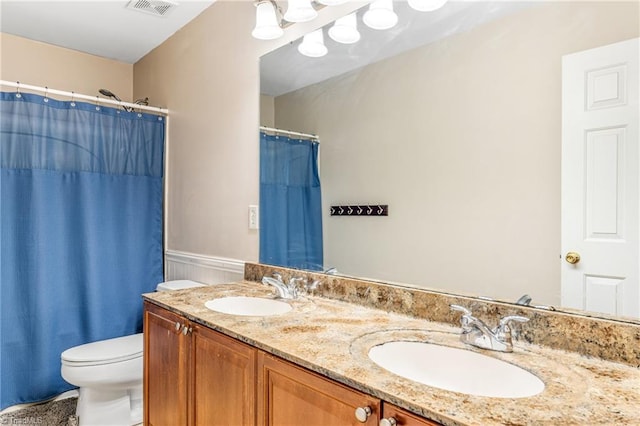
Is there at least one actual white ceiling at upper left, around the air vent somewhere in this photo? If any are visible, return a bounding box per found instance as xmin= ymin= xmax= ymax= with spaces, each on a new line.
xmin=0 ymin=0 xmax=215 ymax=64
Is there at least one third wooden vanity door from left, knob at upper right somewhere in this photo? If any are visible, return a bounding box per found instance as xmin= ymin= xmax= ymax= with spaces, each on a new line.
xmin=258 ymin=352 xmax=380 ymax=426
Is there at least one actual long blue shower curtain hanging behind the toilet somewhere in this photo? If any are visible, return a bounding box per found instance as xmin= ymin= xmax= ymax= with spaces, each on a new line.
xmin=0 ymin=92 xmax=165 ymax=408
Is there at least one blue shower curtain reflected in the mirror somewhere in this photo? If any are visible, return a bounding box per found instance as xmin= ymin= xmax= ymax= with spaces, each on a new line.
xmin=260 ymin=133 xmax=322 ymax=270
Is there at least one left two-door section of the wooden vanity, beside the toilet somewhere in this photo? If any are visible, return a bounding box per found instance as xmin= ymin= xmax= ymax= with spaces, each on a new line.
xmin=144 ymin=302 xmax=257 ymax=426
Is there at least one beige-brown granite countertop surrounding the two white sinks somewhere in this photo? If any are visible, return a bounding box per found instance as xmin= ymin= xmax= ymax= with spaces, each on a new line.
xmin=143 ymin=281 xmax=640 ymax=425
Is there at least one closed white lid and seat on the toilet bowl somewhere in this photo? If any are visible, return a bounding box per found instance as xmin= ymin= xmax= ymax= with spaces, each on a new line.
xmin=60 ymin=333 xmax=143 ymax=365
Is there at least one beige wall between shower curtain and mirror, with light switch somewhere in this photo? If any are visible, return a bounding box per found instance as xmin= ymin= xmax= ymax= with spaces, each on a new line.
xmin=134 ymin=1 xmax=364 ymax=261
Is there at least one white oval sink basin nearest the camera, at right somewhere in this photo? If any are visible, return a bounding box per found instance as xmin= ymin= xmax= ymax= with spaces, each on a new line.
xmin=369 ymin=341 xmax=544 ymax=398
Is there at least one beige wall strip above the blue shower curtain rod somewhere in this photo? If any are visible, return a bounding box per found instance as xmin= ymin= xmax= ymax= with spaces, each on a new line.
xmin=0 ymin=33 xmax=133 ymax=101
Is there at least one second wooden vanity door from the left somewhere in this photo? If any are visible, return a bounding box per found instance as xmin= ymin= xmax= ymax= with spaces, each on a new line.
xmin=191 ymin=324 xmax=257 ymax=426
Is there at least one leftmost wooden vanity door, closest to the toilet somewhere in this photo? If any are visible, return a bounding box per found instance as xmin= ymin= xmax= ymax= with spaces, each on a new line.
xmin=144 ymin=302 xmax=191 ymax=426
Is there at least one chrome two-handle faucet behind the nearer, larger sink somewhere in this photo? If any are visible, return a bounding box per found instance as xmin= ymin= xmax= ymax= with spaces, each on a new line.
xmin=451 ymin=305 xmax=529 ymax=352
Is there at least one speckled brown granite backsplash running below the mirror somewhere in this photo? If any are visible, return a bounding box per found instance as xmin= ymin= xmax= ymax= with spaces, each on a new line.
xmin=245 ymin=263 xmax=640 ymax=367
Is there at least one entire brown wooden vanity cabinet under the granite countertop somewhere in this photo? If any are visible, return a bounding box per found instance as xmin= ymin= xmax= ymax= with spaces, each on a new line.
xmin=144 ymin=302 xmax=438 ymax=426
